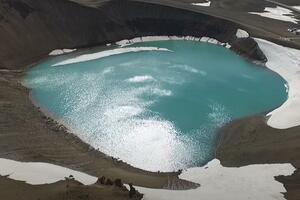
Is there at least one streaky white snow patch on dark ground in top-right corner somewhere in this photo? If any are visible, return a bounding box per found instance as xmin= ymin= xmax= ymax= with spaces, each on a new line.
xmin=249 ymin=6 xmax=299 ymax=24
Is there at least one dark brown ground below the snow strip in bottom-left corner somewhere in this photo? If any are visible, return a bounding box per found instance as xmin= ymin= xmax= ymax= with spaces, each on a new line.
xmin=0 ymin=176 xmax=142 ymax=200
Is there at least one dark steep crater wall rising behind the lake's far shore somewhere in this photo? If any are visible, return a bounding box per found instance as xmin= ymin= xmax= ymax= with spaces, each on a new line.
xmin=0 ymin=0 xmax=264 ymax=69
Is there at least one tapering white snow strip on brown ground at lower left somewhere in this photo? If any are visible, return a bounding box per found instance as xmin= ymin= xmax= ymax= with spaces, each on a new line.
xmin=0 ymin=158 xmax=97 ymax=185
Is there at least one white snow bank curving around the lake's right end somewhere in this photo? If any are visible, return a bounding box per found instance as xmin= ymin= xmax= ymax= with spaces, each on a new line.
xmin=256 ymin=39 xmax=300 ymax=129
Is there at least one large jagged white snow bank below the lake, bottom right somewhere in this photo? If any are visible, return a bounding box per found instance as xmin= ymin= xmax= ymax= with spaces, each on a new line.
xmin=137 ymin=159 xmax=295 ymax=200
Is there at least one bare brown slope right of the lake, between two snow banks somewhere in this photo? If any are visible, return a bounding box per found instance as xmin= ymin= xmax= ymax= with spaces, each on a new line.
xmin=216 ymin=116 xmax=300 ymax=200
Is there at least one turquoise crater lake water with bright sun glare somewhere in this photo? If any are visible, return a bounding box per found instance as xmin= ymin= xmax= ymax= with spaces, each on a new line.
xmin=25 ymin=41 xmax=287 ymax=171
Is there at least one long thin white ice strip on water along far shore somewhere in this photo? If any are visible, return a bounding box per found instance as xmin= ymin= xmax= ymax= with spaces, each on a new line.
xmin=52 ymin=47 xmax=170 ymax=66
